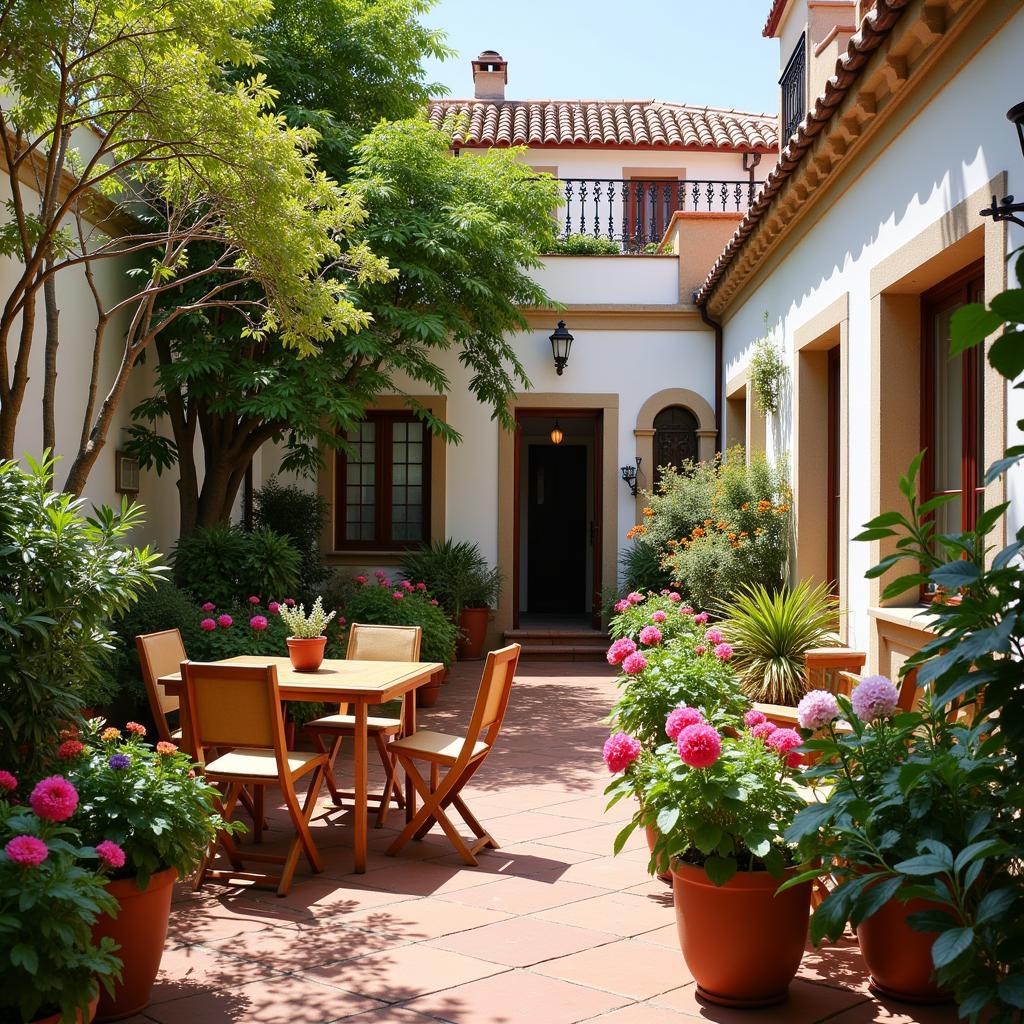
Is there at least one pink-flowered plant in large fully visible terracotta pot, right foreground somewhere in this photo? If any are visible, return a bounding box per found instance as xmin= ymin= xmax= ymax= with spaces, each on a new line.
xmin=615 ymin=709 xmax=811 ymax=1007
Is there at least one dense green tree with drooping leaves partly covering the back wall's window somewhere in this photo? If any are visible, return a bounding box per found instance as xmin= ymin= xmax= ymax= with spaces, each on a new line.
xmin=131 ymin=120 xmax=559 ymax=535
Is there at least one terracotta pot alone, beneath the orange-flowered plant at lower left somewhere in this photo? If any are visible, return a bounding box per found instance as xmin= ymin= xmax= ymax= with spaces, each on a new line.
xmin=92 ymin=867 xmax=178 ymax=1021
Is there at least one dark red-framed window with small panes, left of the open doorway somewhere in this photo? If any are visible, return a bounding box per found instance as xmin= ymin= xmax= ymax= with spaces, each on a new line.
xmin=335 ymin=413 xmax=430 ymax=550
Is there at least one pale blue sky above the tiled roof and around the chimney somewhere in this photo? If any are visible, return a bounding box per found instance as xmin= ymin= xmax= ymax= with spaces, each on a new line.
xmin=424 ymin=0 xmax=778 ymax=113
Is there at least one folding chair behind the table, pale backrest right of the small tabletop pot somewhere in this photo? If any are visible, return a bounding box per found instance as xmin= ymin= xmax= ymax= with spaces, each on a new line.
xmin=306 ymin=623 xmax=423 ymax=828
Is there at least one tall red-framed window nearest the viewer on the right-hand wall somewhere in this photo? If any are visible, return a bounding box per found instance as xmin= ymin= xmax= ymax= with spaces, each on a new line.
xmin=921 ymin=264 xmax=985 ymax=596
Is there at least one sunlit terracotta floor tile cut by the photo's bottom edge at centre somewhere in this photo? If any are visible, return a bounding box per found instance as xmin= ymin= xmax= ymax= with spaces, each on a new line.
xmin=409 ymin=971 xmax=626 ymax=1024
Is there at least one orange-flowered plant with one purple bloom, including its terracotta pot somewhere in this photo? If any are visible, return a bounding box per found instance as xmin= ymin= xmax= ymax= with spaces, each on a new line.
xmin=65 ymin=719 xmax=243 ymax=1020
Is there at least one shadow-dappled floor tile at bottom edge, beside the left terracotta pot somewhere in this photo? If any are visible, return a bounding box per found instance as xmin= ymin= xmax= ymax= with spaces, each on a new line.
xmin=145 ymin=975 xmax=381 ymax=1024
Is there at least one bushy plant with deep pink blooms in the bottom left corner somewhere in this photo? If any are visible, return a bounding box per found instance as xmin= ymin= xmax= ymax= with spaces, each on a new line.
xmin=0 ymin=771 xmax=121 ymax=1024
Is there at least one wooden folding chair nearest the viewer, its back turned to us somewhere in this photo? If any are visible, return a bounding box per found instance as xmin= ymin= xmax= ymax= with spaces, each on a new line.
xmin=181 ymin=662 xmax=327 ymax=896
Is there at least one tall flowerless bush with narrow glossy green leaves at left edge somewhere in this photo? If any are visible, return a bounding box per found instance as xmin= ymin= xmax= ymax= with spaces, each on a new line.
xmin=0 ymin=454 xmax=161 ymax=776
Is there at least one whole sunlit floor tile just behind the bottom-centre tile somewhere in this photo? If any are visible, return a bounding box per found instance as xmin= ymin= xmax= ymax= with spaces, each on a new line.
xmin=428 ymin=918 xmax=614 ymax=967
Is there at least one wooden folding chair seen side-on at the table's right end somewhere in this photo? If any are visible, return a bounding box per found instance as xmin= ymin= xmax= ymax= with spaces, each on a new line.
xmin=387 ymin=643 xmax=522 ymax=866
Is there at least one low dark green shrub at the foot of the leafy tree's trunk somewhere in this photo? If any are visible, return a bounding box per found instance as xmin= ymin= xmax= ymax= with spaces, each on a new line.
xmin=172 ymin=525 xmax=302 ymax=605
